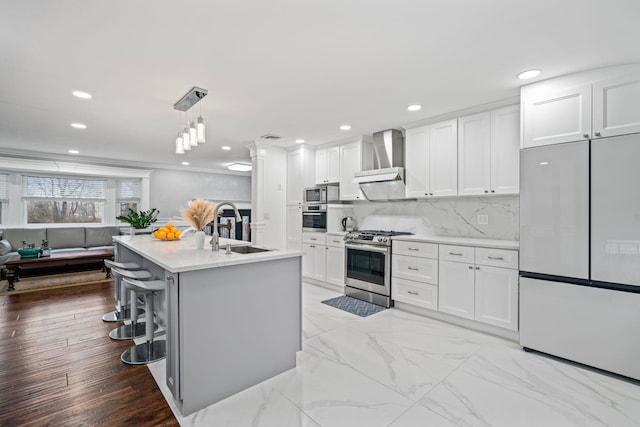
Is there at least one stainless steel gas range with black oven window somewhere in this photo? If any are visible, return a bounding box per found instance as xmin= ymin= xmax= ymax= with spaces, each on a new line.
xmin=344 ymin=230 xmax=411 ymax=307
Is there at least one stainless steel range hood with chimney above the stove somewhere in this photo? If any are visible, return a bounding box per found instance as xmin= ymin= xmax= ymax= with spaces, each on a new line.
xmin=353 ymin=129 xmax=405 ymax=200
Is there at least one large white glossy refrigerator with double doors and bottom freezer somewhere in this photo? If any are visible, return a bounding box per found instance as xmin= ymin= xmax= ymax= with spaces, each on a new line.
xmin=520 ymin=134 xmax=640 ymax=380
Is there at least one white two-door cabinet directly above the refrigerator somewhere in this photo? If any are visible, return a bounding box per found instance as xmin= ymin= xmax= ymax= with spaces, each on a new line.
xmin=521 ymin=66 xmax=640 ymax=148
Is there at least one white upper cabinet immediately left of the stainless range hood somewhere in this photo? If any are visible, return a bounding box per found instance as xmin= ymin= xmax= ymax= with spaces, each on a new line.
xmin=340 ymin=139 xmax=373 ymax=200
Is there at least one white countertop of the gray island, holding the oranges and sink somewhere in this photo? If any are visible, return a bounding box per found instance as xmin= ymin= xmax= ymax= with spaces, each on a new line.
xmin=113 ymin=233 xmax=303 ymax=273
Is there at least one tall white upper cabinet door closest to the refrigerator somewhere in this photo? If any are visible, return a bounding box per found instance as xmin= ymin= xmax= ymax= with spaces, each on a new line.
xmin=490 ymin=105 xmax=520 ymax=194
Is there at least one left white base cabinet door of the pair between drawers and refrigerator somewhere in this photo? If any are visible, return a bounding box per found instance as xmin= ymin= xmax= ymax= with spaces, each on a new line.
xmin=438 ymin=261 xmax=475 ymax=319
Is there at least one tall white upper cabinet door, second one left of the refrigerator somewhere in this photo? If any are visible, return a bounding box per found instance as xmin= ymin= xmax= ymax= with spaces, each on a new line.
xmin=458 ymin=113 xmax=488 ymax=196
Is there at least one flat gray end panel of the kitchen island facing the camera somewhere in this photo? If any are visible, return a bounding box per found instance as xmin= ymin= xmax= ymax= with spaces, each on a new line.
xmin=178 ymin=256 xmax=302 ymax=415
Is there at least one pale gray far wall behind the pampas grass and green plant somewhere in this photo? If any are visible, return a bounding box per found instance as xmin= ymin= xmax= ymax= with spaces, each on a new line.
xmin=149 ymin=169 xmax=251 ymax=218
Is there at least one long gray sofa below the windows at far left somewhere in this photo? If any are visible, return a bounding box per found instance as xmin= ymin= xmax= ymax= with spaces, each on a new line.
xmin=0 ymin=226 xmax=120 ymax=277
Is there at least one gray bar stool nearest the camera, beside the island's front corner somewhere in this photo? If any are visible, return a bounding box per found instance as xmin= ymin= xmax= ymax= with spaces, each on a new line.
xmin=120 ymin=277 xmax=167 ymax=365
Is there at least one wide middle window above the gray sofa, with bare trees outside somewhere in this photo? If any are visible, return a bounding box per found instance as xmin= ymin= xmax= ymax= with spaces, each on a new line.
xmin=22 ymin=176 xmax=106 ymax=224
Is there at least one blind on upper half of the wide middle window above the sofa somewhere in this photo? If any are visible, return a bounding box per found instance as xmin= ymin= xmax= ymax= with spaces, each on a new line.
xmin=22 ymin=176 xmax=106 ymax=200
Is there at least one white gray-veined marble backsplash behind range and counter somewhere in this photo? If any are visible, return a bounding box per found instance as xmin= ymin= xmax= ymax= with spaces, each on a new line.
xmin=352 ymin=195 xmax=520 ymax=240
